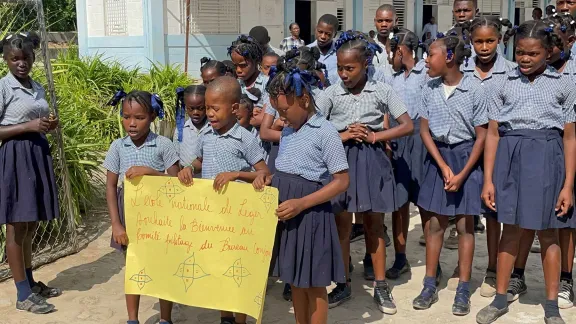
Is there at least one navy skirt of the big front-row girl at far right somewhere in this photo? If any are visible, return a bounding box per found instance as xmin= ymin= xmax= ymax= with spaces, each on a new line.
xmin=493 ymin=129 xmax=571 ymax=230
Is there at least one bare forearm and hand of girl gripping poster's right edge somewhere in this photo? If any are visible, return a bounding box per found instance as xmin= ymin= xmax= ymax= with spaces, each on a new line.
xmin=276 ymin=170 xmax=350 ymax=221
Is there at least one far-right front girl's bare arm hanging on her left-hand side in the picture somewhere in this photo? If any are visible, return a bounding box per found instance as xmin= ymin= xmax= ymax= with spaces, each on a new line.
xmin=482 ymin=120 xmax=500 ymax=211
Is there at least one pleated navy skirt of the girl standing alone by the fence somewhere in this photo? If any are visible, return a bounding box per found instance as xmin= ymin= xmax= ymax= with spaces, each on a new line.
xmin=0 ymin=133 xmax=60 ymax=224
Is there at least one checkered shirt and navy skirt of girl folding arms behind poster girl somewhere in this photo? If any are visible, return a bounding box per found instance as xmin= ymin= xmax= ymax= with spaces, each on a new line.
xmin=316 ymin=79 xmax=407 ymax=213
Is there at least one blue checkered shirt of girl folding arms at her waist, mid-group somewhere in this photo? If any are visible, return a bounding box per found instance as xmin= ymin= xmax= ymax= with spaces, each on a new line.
xmin=316 ymin=79 xmax=407 ymax=131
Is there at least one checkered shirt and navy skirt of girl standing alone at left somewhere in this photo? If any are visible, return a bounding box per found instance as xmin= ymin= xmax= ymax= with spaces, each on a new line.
xmin=0 ymin=72 xmax=60 ymax=224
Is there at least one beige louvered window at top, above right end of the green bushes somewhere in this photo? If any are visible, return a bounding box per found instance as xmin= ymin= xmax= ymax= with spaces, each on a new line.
xmin=187 ymin=0 xmax=240 ymax=34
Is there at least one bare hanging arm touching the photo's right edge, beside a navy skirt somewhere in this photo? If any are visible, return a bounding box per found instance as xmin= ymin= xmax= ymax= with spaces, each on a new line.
xmin=556 ymin=123 xmax=576 ymax=217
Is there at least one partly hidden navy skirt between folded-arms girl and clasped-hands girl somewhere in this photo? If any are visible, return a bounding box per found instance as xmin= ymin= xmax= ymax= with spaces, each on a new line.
xmin=390 ymin=119 xmax=428 ymax=207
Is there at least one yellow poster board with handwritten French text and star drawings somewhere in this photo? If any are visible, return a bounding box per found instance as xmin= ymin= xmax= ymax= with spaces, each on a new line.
xmin=124 ymin=177 xmax=278 ymax=322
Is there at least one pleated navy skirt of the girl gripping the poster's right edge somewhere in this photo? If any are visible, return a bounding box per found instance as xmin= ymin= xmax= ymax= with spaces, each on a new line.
xmin=272 ymin=171 xmax=346 ymax=288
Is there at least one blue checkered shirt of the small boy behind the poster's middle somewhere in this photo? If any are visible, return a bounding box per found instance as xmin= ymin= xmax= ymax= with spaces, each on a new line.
xmin=196 ymin=123 xmax=264 ymax=179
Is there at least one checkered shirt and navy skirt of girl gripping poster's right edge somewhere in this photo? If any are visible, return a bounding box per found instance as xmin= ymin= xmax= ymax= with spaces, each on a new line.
xmin=272 ymin=114 xmax=348 ymax=288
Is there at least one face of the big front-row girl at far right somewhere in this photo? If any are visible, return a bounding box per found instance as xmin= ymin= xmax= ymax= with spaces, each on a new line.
xmin=516 ymin=38 xmax=552 ymax=76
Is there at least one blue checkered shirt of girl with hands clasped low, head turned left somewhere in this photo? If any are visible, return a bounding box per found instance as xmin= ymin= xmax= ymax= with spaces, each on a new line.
xmin=420 ymin=74 xmax=488 ymax=144
